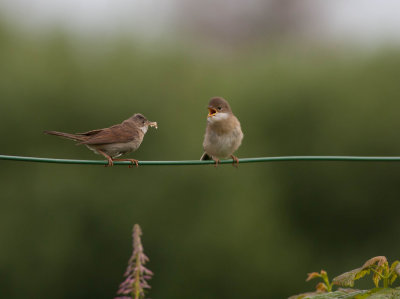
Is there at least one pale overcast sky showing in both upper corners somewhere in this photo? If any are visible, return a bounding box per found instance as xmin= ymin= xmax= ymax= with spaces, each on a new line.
xmin=0 ymin=0 xmax=400 ymax=42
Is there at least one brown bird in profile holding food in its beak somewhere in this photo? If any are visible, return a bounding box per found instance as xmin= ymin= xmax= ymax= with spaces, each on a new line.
xmin=44 ymin=113 xmax=157 ymax=167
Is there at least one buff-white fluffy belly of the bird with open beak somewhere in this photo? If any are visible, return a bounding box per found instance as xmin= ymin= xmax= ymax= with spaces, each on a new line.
xmin=203 ymin=130 xmax=243 ymax=159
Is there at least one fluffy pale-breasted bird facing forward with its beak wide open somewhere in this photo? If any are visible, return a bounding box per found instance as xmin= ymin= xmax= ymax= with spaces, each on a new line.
xmin=200 ymin=97 xmax=243 ymax=167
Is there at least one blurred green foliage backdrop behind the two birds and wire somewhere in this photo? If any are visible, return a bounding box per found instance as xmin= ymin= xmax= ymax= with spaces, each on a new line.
xmin=0 ymin=1 xmax=400 ymax=299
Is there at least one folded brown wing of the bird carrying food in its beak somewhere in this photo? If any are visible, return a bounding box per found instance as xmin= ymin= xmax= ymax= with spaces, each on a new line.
xmin=81 ymin=124 xmax=140 ymax=144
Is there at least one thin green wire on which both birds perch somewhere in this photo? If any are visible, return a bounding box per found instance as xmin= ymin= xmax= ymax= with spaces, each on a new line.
xmin=0 ymin=155 xmax=400 ymax=165
